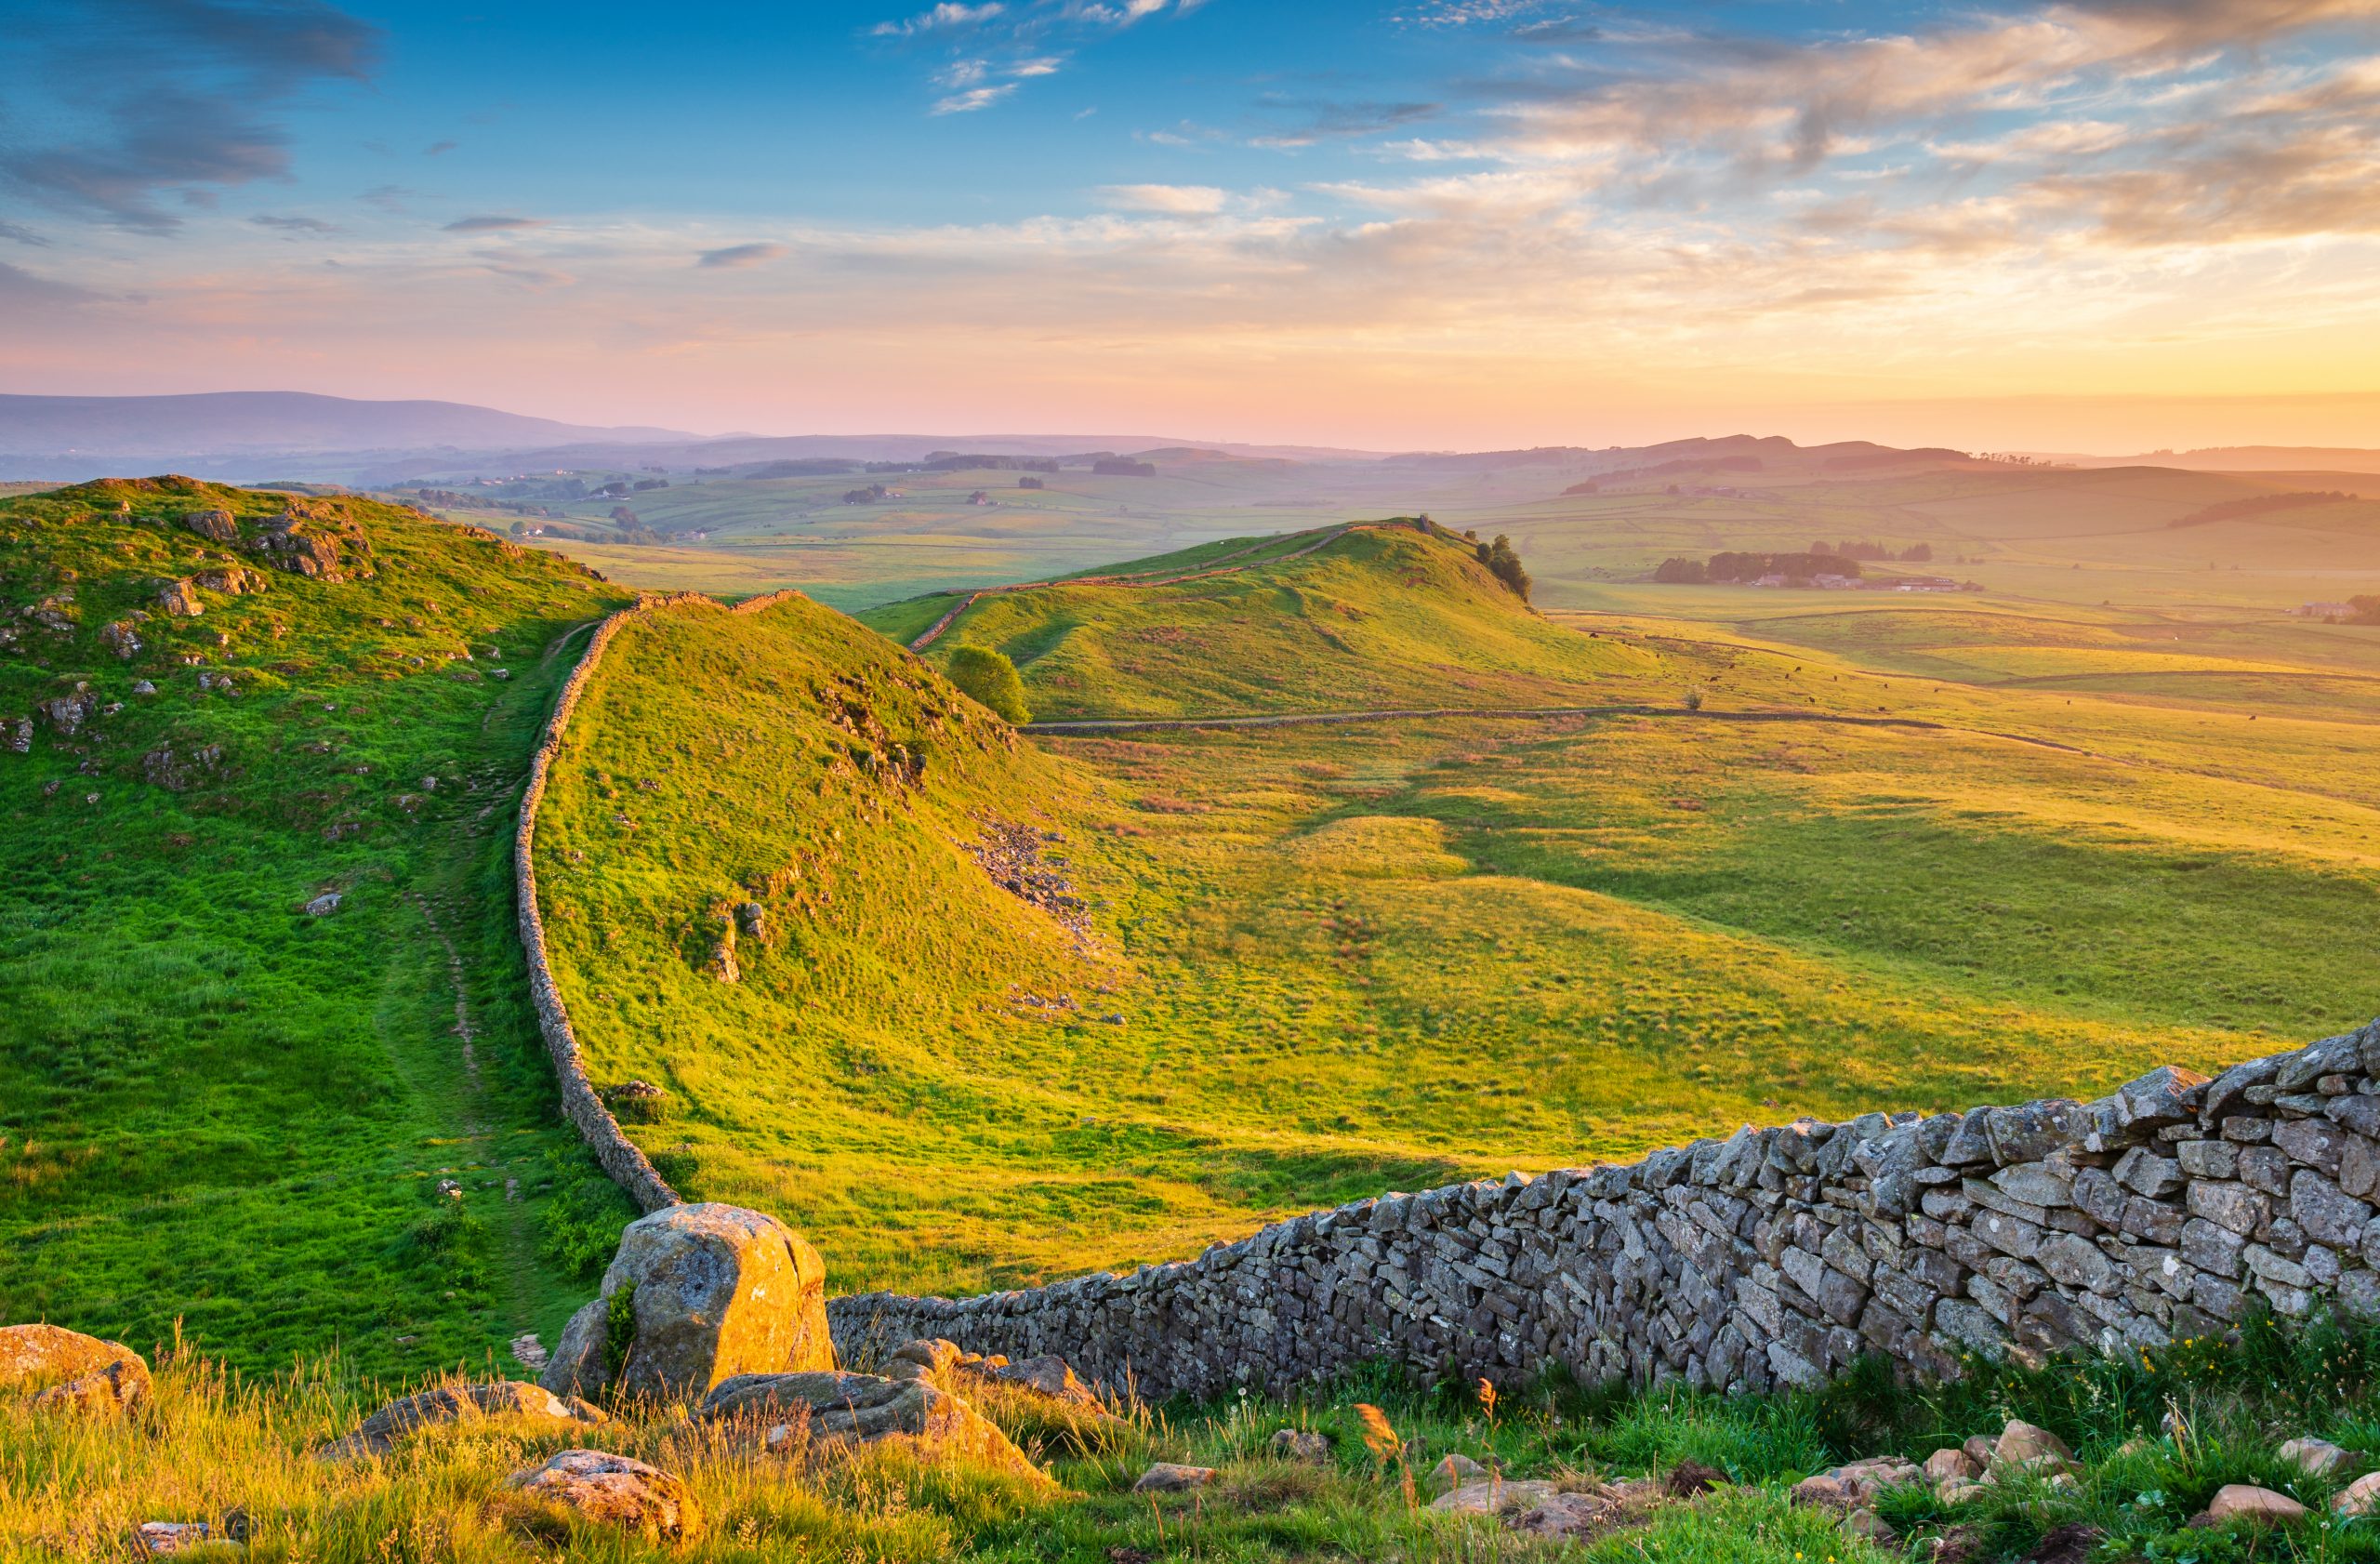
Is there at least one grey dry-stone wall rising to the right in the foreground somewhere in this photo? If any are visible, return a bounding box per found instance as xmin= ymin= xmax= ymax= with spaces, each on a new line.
xmin=828 ymin=1021 xmax=2380 ymax=1395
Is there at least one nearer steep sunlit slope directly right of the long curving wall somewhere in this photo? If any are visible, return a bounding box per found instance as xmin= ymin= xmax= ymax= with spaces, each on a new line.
xmin=536 ymin=598 xmax=1112 ymax=1285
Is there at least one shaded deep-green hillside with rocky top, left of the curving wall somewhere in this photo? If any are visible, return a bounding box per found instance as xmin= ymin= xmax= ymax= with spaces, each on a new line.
xmin=0 ymin=479 xmax=642 ymax=1369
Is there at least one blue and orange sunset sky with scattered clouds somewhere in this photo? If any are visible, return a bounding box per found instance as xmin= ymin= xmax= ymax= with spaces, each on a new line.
xmin=0 ymin=0 xmax=2380 ymax=452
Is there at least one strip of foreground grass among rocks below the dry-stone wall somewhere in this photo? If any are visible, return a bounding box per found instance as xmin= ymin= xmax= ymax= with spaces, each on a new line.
xmin=22 ymin=1319 xmax=2380 ymax=1564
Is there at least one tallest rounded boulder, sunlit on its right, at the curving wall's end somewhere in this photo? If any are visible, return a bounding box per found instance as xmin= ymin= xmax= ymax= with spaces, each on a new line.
xmin=538 ymin=1204 xmax=836 ymax=1399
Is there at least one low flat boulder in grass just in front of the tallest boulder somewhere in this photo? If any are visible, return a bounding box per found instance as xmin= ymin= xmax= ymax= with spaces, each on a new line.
xmin=695 ymin=1373 xmax=1042 ymax=1478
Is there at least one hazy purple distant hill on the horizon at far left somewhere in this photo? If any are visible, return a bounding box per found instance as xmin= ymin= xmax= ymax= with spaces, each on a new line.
xmin=0 ymin=391 xmax=695 ymax=457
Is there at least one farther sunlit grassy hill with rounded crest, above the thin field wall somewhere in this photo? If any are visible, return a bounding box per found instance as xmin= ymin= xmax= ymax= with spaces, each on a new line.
xmin=862 ymin=524 xmax=1683 ymax=719
